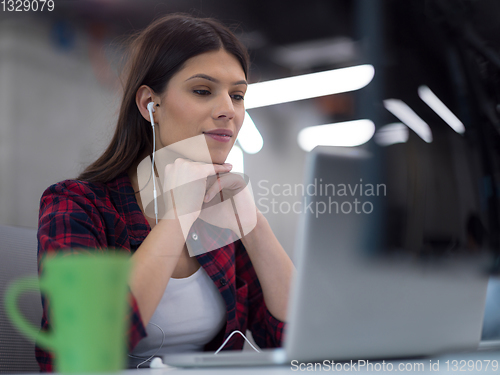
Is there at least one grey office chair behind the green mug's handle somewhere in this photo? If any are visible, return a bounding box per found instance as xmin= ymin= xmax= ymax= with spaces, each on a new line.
xmin=0 ymin=225 xmax=42 ymax=373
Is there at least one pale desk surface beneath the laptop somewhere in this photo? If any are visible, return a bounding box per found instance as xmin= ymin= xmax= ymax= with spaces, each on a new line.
xmin=121 ymin=350 xmax=500 ymax=375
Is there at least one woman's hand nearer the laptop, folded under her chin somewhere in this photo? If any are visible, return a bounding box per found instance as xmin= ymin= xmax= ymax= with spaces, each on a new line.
xmin=200 ymin=173 xmax=257 ymax=238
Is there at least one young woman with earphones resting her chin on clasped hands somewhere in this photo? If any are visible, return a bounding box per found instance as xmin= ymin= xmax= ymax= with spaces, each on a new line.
xmin=37 ymin=15 xmax=293 ymax=371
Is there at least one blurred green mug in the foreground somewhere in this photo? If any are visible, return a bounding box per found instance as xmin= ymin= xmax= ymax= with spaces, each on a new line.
xmin=5 ymin=253 xmax=130 ymax=373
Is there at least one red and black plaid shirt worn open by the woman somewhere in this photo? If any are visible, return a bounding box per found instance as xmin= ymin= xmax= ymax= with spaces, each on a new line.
xmin=36 ymin=173 xmax=285 ymax=371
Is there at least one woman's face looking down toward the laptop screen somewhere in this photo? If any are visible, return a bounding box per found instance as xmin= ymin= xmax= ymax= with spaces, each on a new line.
xmin=155 ymin=49 xmax=247 ymax=164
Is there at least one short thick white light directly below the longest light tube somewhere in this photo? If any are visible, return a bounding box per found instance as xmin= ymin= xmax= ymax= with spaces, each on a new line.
xmin=297 ymin=120 xmax=375 ymax=151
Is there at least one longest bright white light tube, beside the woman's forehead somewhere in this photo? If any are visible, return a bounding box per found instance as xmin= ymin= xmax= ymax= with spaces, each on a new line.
xmin=245 ymin=64 xmax=375 ymax=109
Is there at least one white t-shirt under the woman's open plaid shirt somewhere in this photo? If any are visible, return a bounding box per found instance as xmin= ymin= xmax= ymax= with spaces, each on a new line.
xmin=131 ymin=267 xmax=226 ymax=359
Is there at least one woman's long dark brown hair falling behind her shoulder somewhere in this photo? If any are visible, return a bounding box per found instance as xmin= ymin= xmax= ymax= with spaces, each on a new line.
xmin=77 ymin=14 xmax=249 ymax=183
